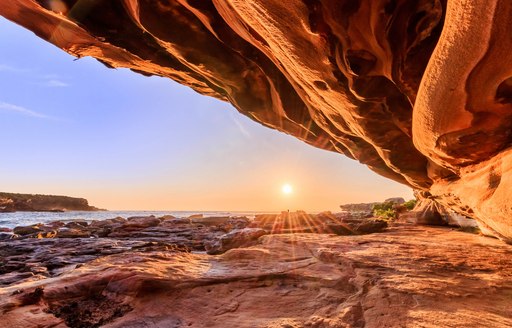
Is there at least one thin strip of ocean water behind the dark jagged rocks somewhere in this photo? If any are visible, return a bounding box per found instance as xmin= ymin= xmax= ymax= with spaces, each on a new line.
xmin=0 ymin=211 xmax=275 ymax=229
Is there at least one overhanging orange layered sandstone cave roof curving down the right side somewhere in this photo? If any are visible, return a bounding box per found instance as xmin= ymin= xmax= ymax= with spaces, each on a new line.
xmin=0 ymin=0 xmax=512 ymax=240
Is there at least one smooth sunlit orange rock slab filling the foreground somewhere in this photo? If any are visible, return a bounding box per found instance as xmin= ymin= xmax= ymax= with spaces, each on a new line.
xmin=0 ymin=225 xmax=512 ymax=328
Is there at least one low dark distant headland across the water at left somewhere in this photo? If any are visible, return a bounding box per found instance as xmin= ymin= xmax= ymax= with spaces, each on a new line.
xmin=0 ymin=192 xmax=104 ymax=213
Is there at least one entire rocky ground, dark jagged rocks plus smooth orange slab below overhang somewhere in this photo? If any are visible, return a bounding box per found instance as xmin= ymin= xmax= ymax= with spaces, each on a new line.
xmin=0 ymin=212 xmax=512 ymax=328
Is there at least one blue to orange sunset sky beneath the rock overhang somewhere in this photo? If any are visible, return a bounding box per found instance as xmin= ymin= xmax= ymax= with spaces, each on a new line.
xmin=0 ymin=17 xmax=412 ymax=212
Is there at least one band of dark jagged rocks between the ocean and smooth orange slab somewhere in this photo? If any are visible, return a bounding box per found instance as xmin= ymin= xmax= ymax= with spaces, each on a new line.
xmin=0 ymin=212 xmax=387 ymax=287
